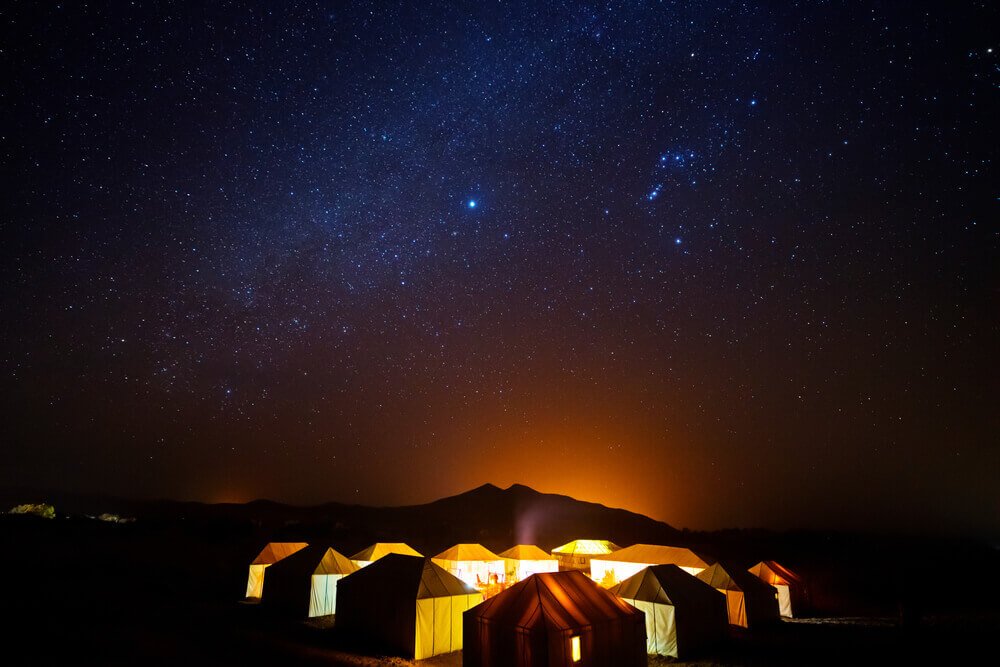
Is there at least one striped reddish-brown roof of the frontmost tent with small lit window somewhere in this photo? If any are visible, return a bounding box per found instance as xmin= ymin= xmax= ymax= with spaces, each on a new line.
xmin=465 ymin=571 xmax=643 ymax=630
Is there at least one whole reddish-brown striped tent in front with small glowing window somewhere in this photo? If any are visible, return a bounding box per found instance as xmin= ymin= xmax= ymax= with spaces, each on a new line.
xmin=462 ymin=571 xmax=646 ymax=667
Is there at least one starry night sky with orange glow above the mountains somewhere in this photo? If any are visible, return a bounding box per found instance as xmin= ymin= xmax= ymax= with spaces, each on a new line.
xmin=0 ymin=0 xmax=1000 ymax=537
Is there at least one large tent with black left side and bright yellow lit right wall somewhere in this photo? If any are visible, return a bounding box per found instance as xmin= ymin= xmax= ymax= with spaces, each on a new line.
xmin=337 ymin=554 xmax=483 ymax=660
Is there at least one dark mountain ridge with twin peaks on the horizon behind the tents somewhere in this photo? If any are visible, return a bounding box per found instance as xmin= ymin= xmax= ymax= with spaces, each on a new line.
xmin=0 ymin=484 xmax=680 ymax=555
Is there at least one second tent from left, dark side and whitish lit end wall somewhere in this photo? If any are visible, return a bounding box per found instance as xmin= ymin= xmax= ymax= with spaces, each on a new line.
xmin=261 ymin=545 xmax=358 ymax=617
